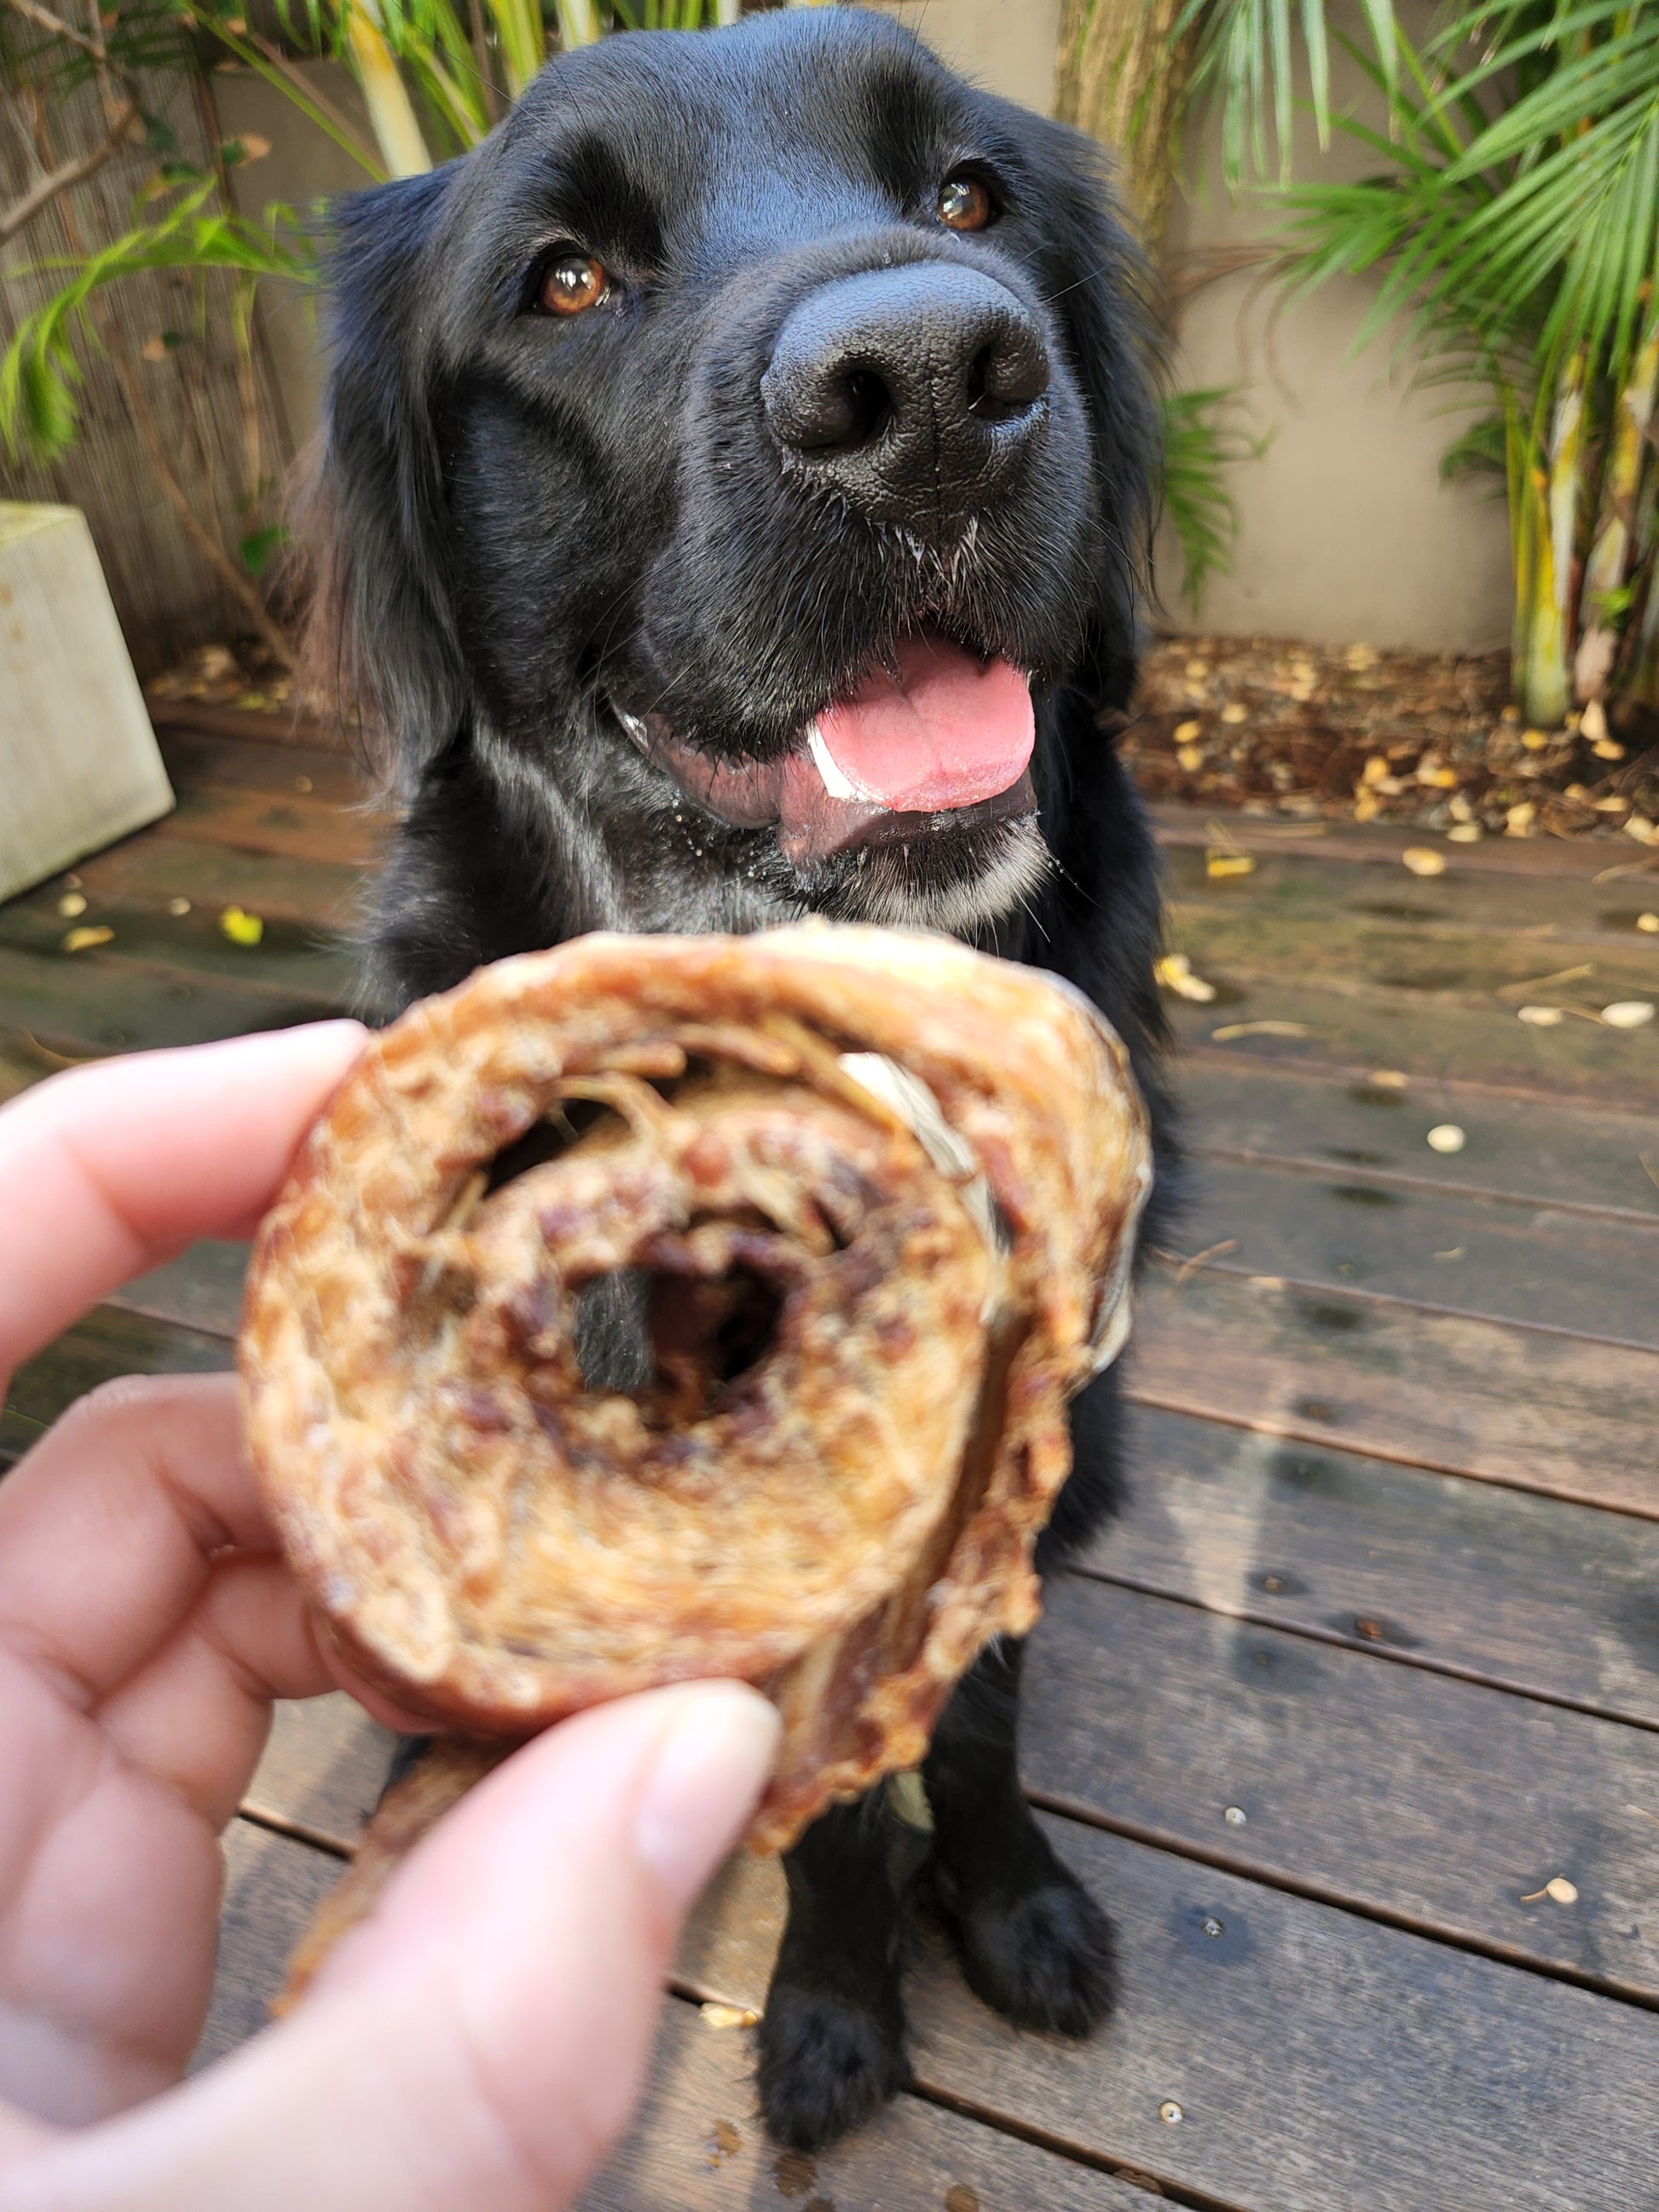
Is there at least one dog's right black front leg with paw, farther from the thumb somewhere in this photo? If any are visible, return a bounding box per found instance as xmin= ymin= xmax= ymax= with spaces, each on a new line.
xmin=922 ymin=1637 xmax=1113 ymax=2035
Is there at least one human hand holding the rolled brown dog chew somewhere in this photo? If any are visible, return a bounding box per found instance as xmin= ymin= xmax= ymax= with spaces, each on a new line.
xmin=0 ymin=1022 xmax=777 ymax=2212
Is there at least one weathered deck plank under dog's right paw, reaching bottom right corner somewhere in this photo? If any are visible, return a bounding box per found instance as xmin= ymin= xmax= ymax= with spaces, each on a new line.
xmin=681 ymin=1818 xmax=1659 ymax=2212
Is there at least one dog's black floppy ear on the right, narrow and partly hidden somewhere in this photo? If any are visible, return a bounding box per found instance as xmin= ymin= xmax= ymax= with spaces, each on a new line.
xmin=1033 ymin=119 xmax=1161 ymax=706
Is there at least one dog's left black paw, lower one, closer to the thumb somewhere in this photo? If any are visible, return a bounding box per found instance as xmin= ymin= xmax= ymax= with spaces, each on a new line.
xmin=756 ymin=1982 xmax=909 ymax=2150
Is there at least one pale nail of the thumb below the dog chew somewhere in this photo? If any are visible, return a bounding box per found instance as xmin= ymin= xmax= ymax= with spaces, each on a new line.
xmin=635 ymin=1681 xmax=781 ymax=1907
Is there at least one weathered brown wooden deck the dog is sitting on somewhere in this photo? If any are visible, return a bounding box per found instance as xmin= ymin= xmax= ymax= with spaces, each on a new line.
xmin=0 ymin=712 xmax=1659 ymax=2212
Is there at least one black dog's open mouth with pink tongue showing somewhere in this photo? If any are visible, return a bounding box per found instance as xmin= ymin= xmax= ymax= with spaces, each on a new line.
xmin=617 ymin=631 xmax=1035 ymax=867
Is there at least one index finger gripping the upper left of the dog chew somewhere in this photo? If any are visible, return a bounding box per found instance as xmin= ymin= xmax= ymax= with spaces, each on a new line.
xmin=0 ymin=1022 xmax=365 ymax=1380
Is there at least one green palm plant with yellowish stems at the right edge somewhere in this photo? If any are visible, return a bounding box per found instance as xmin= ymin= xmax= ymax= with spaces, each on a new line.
xmin=1283 ymin=0 xmax=1659 ymax=725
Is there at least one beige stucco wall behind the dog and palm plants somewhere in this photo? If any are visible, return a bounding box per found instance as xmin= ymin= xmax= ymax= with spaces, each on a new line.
xmin=215 ymin=0 xmax=1509 ymax=648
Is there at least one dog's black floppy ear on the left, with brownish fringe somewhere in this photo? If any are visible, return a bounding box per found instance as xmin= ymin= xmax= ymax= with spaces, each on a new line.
xmin=301 ymin=164 xmax=465 ymax=792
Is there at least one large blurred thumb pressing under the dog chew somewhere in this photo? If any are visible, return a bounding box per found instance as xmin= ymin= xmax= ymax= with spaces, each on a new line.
xmin=11 ymin=1684 xmax=778 ymax=2212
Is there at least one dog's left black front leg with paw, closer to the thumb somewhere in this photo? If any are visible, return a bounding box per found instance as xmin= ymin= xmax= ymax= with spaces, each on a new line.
xmin=759 ymin=1788 xmax=909 ymax=2150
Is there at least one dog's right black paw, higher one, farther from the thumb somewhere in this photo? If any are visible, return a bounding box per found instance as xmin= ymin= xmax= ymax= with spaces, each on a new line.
xmin=942 ymin=1860 xmax=1117 ymax=2037
